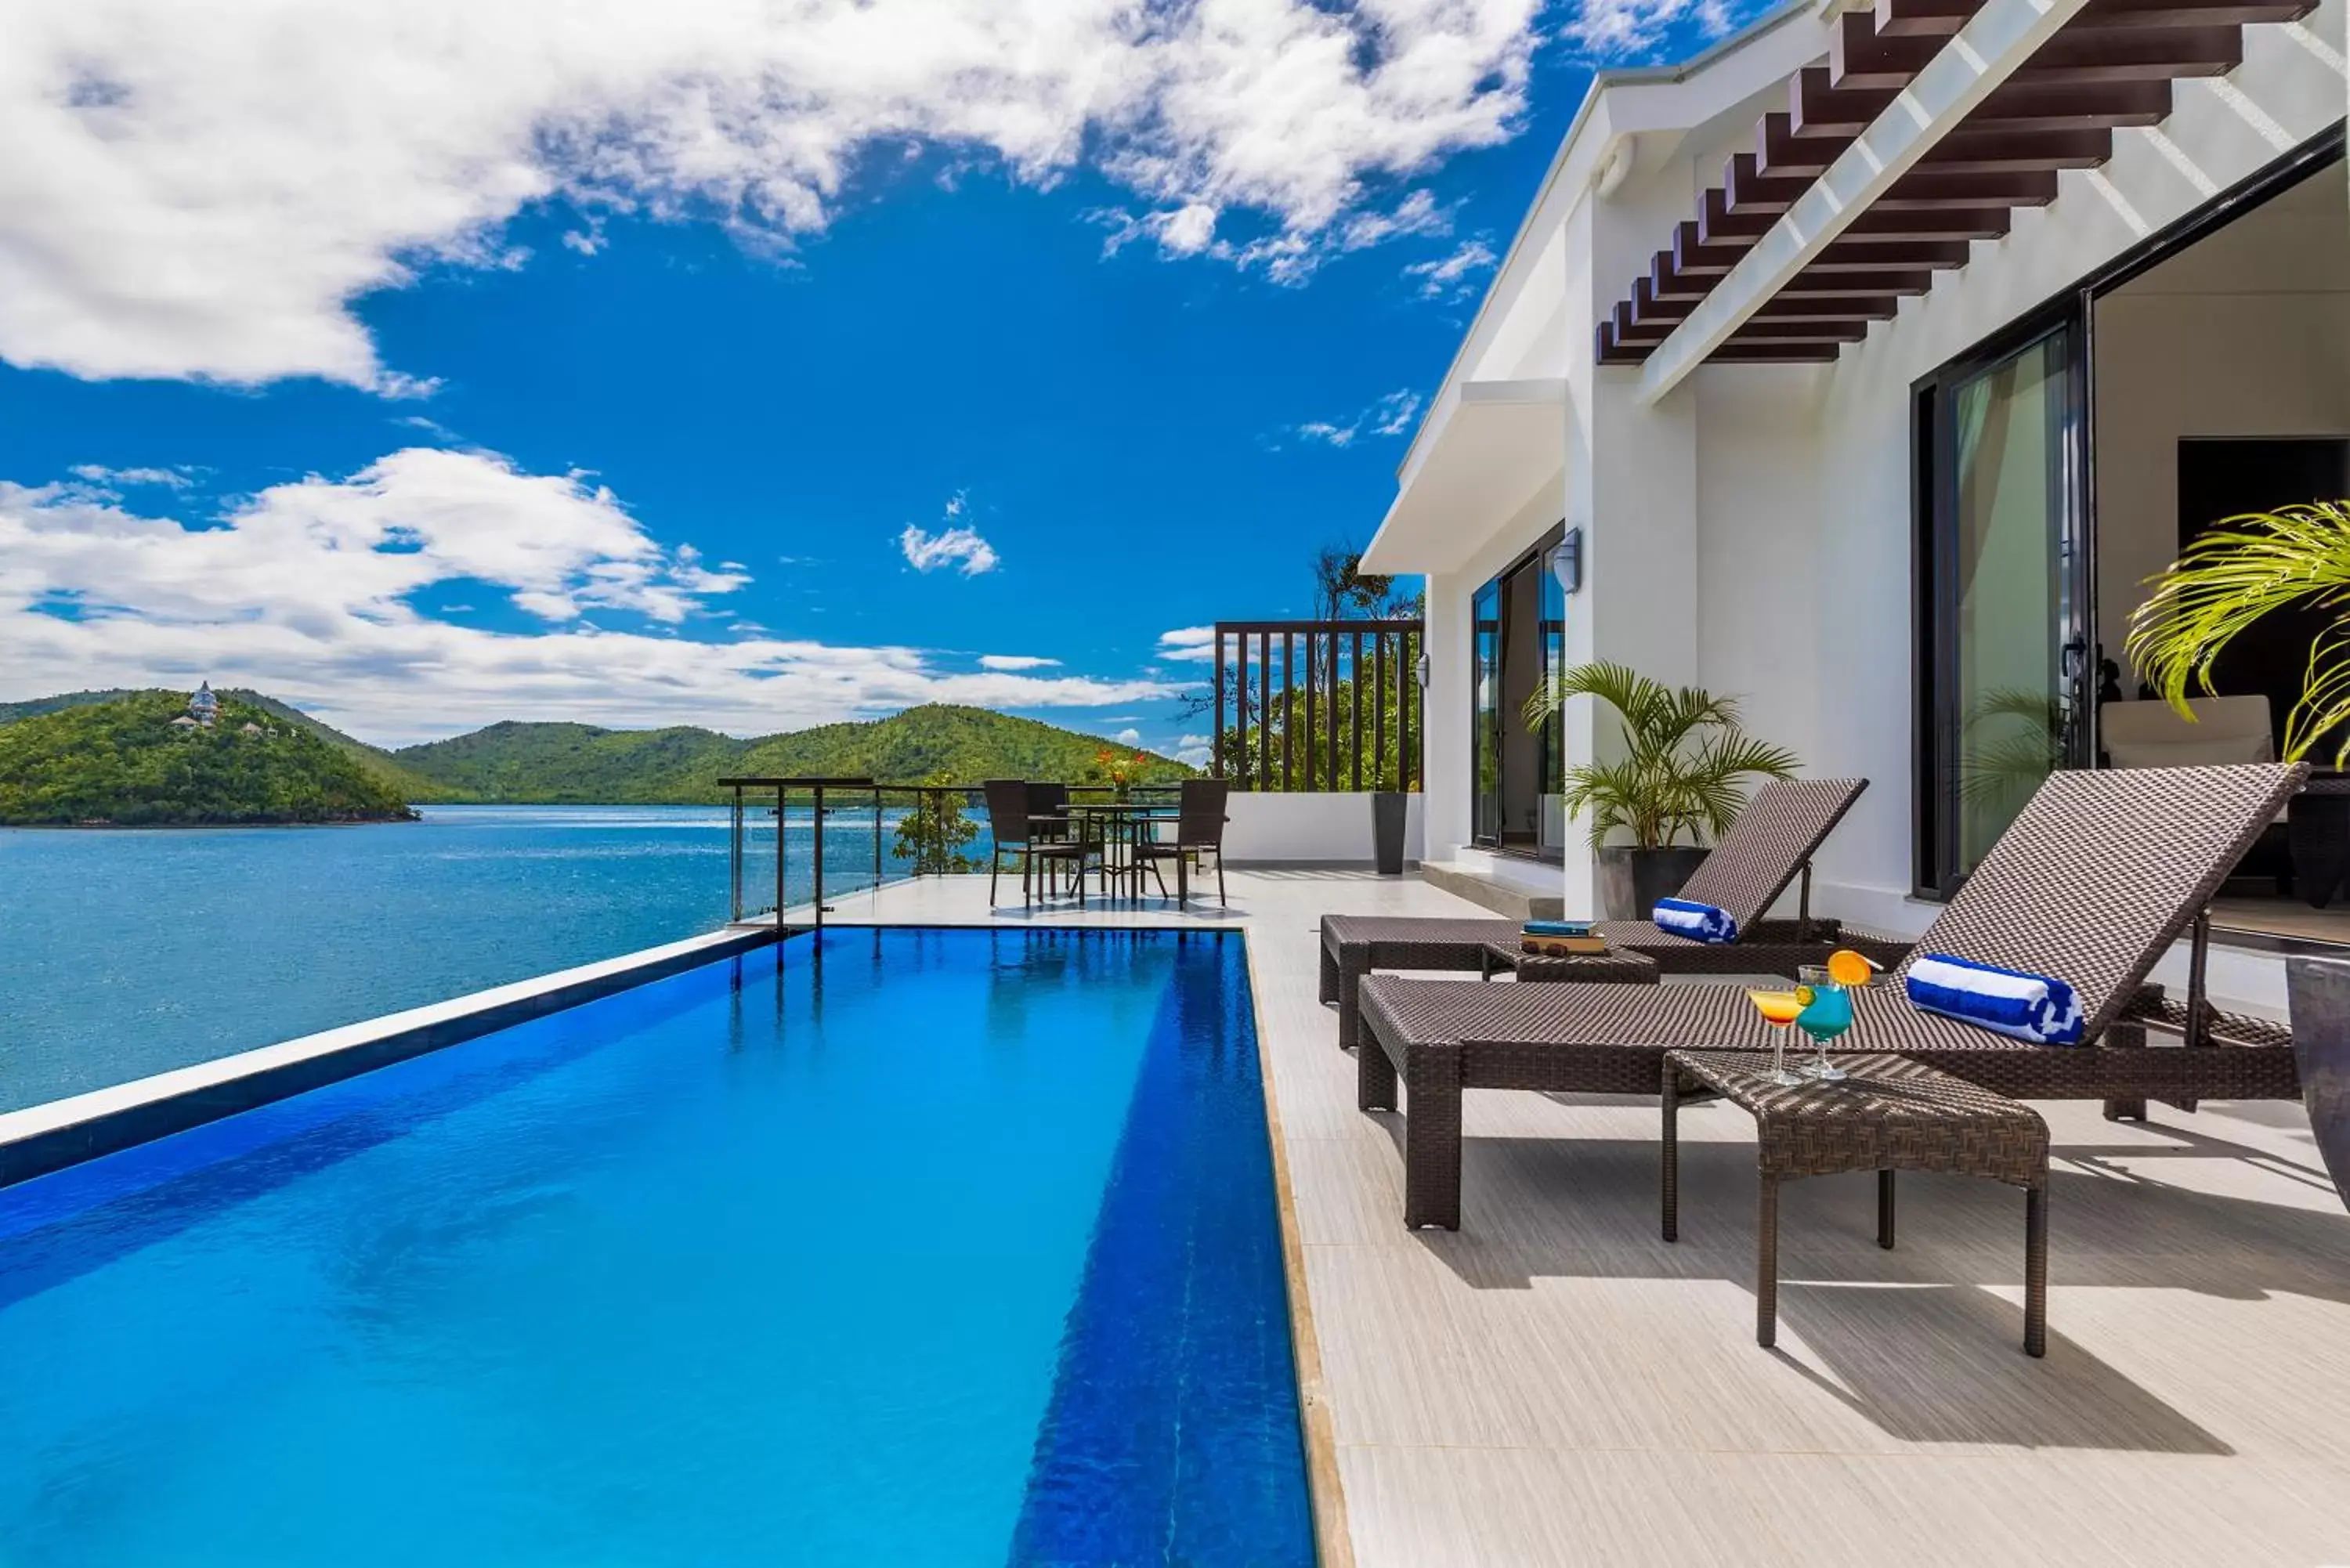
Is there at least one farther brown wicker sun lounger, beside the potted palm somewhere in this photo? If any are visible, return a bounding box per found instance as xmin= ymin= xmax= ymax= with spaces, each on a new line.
xmin=1321 ymin=778 xmax=1880 ymax=1049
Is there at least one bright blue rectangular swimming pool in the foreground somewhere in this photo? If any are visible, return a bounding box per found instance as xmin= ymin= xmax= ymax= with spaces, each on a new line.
xmin=0 ymin=929 xmax=1311 ymax=1568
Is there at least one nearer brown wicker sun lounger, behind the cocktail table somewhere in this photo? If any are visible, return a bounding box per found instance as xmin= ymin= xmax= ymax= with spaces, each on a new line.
xmin=1356 ymin=766 xmax=2308 ymax=1227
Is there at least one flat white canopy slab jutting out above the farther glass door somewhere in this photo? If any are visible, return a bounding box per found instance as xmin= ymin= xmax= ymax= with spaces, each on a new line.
xmin=1363 ymin=378 xmax=1567 ymax=573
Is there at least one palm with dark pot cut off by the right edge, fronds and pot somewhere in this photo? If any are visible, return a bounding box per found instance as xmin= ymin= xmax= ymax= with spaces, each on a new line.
xmin=2129 ymin=500 xmax=2350 ymax=1199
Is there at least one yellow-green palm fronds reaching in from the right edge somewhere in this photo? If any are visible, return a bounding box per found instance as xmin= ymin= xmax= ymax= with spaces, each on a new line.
xmin=2129 ymin=500 xmax=2350 ymax=766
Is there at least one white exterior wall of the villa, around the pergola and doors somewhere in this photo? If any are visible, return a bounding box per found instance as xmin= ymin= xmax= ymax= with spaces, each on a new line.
xmin=1382 ymin=0 xmax=2350 ymax=963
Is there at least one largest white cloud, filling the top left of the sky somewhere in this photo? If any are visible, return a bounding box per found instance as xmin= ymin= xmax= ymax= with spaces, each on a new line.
xmin=0 ymin=0 xmax=1551 ymax=395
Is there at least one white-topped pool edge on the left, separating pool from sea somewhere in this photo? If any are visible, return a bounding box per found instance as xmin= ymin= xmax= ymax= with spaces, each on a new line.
xmin=0 ymin=927 xmax=780 ymax=1187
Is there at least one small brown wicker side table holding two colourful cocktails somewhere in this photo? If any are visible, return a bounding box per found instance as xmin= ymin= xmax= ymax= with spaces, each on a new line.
xmin=1664 ymin=1051 xmax=2049 ymax=1357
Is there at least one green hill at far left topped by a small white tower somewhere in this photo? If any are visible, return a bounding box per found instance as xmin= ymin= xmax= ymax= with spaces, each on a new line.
xmin=0 ymin=691 xmax=414 ymax=828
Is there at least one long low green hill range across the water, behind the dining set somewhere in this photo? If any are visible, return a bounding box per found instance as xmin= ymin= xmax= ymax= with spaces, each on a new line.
xmin=390 ymin=703 xmax=1191 ymax=804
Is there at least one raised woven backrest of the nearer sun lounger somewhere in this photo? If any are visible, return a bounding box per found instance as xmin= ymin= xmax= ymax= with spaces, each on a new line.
xmin=1896 ymin=761 xmax=2308 ymax=1039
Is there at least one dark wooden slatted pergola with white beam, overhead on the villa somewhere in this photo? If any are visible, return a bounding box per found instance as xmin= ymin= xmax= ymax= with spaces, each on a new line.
xmin=1596 ymin=0 xmax=2319 ymax=371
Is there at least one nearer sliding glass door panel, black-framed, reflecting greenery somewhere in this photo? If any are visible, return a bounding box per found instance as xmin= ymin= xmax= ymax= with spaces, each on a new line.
xmin=1918 ymin=317 xmax=2092 ymax=898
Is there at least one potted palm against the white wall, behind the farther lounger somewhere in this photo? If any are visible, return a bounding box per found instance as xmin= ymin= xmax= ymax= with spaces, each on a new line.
xmin=1525 ymin=660 xmax=1800 ymax=919
